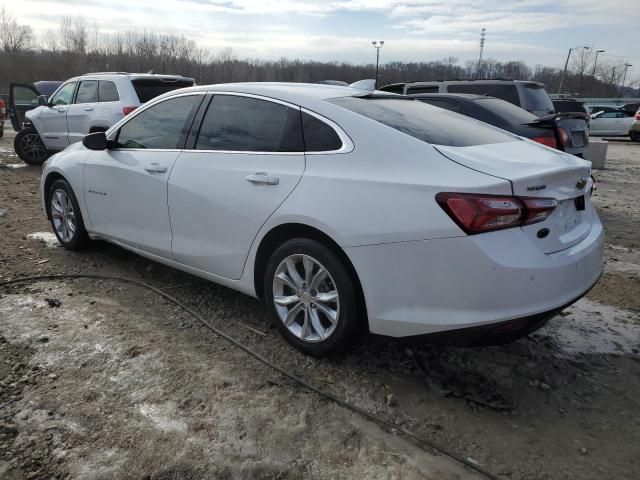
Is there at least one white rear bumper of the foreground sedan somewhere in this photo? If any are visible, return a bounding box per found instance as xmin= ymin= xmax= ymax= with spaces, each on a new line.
xmin=347 ymin=215 xmax=604 ymax=337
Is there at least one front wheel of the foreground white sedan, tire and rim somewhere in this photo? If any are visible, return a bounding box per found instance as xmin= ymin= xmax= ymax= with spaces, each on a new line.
xmin=47 ymin=179 xmax=89 ymax=250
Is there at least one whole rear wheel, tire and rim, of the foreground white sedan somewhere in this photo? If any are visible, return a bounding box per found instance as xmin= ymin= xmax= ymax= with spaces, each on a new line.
xmin=264 ymin=238 xmax=358 ymax=356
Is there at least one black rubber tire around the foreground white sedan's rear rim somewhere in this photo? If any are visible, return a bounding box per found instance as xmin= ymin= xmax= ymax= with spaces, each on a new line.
xmin=264 ymin=238 xmax=360 ymax=357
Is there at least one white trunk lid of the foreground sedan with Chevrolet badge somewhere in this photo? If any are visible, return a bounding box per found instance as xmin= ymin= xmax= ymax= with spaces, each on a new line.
xmin=435 ymin=140 xmax=594 ymax=253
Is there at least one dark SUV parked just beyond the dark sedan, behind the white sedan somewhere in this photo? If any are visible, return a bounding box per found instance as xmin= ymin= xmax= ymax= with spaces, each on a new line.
xmin=380 ymin=80 xmax=555 ymax=117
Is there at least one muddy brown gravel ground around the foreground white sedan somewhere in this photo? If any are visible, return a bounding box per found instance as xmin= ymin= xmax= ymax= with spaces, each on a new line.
xmin=0 ymin=128 xmax=640 ymax=480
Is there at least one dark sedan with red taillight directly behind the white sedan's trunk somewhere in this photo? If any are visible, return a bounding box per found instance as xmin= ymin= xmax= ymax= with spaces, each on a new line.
xmin=410 ymin=93 xmax=589 ymax=157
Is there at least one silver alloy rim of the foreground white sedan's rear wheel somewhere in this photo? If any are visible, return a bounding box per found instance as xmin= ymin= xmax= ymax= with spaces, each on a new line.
xmin=273 ymin=254 xmax=340 ymax=343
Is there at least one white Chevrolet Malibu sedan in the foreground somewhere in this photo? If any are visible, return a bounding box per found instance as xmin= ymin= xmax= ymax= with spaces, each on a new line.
xmin=41 ymin=83 xmax=604 ymax=355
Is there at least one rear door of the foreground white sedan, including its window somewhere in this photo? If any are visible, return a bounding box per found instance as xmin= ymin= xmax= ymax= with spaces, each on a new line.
xmin=168 ymin=94 xmax=305 ymax=279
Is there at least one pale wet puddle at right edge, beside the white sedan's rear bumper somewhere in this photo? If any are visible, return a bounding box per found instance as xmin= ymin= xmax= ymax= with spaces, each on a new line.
xmin=534 ymin=298 xmax=640 ymax=357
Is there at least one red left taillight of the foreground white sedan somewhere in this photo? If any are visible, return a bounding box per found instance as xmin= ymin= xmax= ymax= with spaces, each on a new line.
xmin=436 ymin=192 xmax=558 ymax=235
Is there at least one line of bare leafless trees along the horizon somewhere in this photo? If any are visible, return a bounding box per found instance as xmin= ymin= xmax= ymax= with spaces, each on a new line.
xmin=0 ymin=7 xmax=640 ymax=97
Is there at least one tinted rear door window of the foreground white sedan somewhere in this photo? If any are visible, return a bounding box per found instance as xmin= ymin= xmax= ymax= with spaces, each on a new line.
xmin=195 ymin=95 xmax=304 ymax=152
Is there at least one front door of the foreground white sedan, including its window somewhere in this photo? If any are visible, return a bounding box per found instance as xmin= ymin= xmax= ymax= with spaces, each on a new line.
xmin=84 ymin=94 xmax=203 ymax=258
